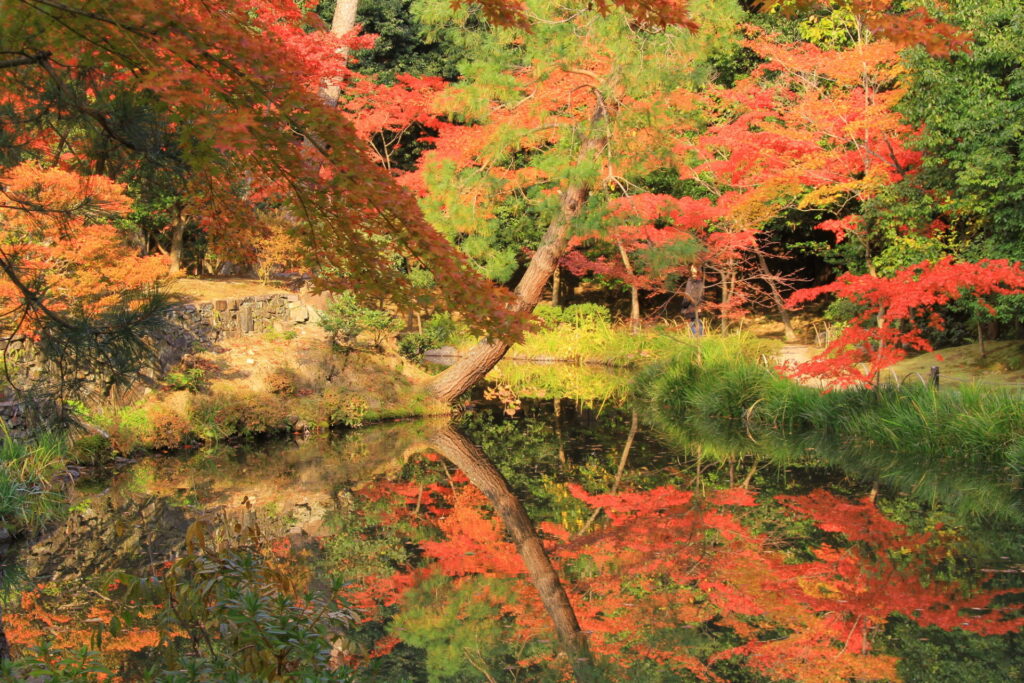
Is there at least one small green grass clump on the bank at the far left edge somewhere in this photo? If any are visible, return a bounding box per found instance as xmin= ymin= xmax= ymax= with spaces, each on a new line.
xmin=0 ymin=433 xmax=67 ymax=533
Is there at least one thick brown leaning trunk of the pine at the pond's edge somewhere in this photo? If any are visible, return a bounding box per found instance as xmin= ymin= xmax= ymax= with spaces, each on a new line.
xmin=428 ymin=104 xmax=607 ymax=400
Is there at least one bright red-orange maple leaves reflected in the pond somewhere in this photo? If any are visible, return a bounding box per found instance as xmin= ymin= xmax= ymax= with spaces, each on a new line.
xmin=346 ymin=471 xmax=1024 ymax=681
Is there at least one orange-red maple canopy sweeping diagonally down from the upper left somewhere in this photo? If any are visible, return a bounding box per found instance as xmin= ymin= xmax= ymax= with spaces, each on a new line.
xmin=0 ymin=0 xmax=519 ymax=332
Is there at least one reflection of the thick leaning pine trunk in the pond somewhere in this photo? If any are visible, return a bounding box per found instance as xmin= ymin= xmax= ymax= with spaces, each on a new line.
xmin=430 ymin=426 xmax=594 ymax=681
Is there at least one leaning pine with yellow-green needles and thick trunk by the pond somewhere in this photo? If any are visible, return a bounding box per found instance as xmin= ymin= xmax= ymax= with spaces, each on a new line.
xmin=422 ymin=0 xmax=740 ymax=398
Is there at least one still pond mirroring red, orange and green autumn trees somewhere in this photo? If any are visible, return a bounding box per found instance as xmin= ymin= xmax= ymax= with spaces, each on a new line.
xmin=5 ymin=370 xmax=1024 ymax=681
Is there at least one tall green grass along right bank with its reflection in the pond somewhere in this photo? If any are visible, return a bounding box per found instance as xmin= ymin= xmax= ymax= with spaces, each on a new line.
xmin=634 ymin=338 xmax=1024 ymax=519
